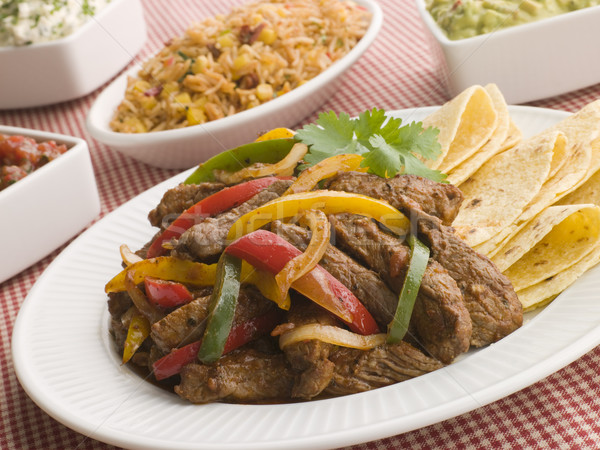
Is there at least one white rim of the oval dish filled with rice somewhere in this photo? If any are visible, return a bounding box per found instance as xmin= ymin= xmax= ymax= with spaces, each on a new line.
xmin=86 ymin=0 xmax=383 ymax=146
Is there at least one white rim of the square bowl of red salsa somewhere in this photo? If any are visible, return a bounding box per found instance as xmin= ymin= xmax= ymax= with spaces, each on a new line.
xmin=0 ymin=125 xmax=89 ymax=200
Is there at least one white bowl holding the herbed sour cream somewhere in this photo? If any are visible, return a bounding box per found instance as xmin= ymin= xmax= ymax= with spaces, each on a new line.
xmin=0 ymin=0 xmax=146 ymax=109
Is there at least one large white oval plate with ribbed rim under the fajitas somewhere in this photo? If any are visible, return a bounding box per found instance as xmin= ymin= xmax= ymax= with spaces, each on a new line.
xmin=12 ymin=107 xmax=600 ymax=450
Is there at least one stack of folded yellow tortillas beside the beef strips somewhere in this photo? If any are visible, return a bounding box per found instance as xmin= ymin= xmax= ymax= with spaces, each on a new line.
xmin=423 ymin=85 xmax=600 ymax=310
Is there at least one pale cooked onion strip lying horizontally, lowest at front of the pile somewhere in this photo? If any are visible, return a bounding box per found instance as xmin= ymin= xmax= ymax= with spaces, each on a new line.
xmin=271 ymin=323 xmax=386 ymax=350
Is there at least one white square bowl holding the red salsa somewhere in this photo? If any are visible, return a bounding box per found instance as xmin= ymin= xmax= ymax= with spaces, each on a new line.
xmin=0 ymin=126 xmax=100 ymax=283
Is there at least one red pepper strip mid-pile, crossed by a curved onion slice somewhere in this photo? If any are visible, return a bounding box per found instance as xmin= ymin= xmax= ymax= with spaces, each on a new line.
xmin=225 ymin=230 xmax=379 ymax=334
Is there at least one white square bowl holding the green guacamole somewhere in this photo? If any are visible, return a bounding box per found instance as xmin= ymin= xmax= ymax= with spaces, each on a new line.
xmin=415 ymin=0 xmax=600 ymax=104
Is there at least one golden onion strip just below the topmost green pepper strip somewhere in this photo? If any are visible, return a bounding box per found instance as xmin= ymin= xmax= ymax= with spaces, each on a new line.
xmin=214 ymin=143 xmax=308 ymax=184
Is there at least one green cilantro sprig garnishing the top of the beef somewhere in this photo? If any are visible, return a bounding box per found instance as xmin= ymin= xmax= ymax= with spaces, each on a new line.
xmin=295 ymin=108 xmax=446 ymax=181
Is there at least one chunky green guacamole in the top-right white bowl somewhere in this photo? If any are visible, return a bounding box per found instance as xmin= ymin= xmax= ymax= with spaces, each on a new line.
xmin=425 ymin=0 xmax=600 ymax=40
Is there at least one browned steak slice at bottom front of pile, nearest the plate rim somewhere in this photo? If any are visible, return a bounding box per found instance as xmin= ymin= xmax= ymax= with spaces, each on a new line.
xmin=175 ymin=349 xmax=295 ymax=403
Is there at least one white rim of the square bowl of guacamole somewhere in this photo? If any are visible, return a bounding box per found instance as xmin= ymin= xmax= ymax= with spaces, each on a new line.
xmin=414 ymin=0 xmax=600 ymax=47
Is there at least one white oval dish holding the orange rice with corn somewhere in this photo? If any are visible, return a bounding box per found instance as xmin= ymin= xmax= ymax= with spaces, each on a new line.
xmin=87 ymin=0 xmax=383 ymax=169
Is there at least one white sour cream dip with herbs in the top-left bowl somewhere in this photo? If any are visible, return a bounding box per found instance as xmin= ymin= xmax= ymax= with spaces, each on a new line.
xmin=0 ymin=0 xmax=110 ymax=47
